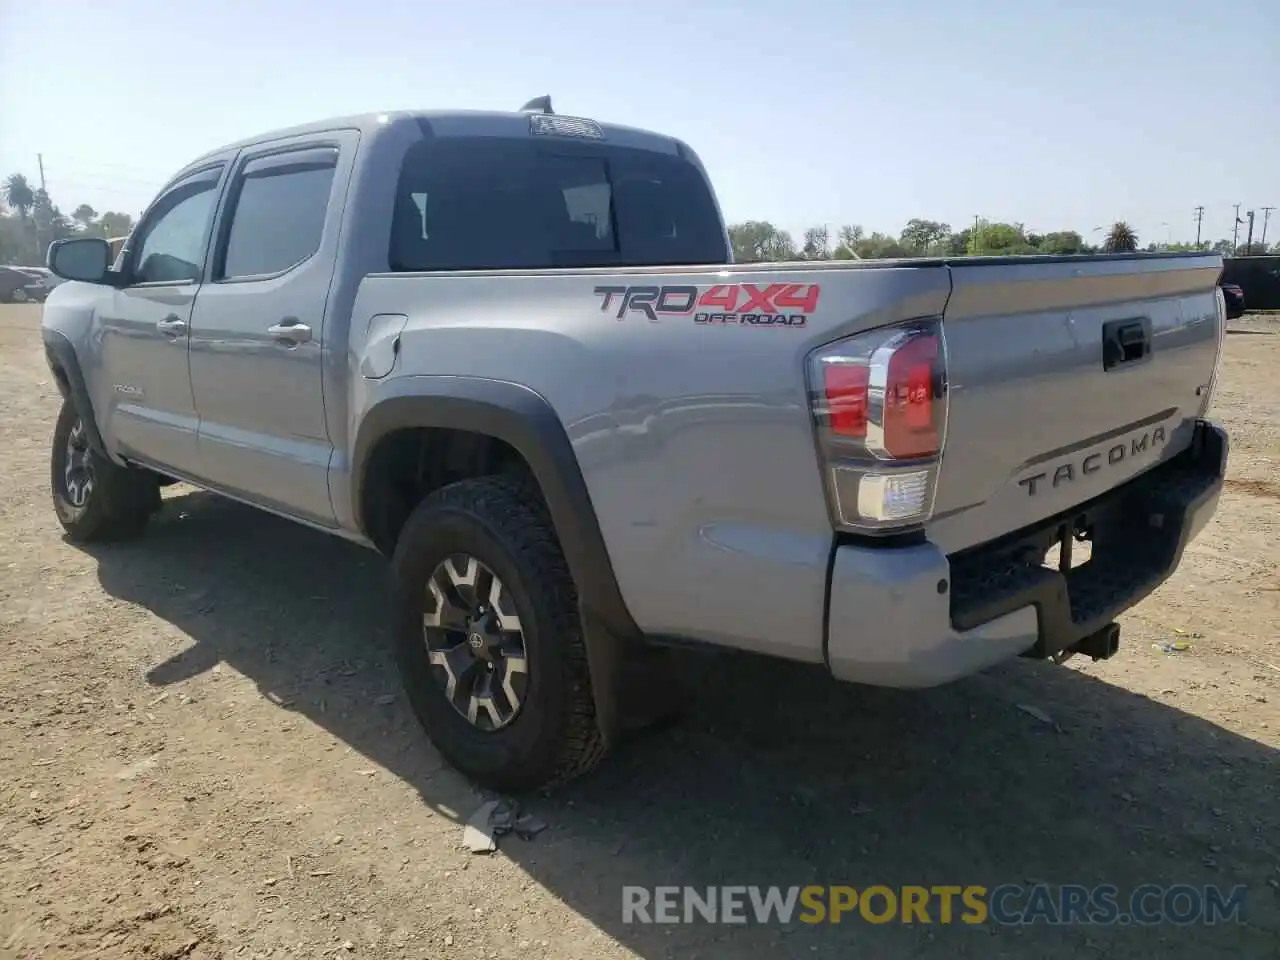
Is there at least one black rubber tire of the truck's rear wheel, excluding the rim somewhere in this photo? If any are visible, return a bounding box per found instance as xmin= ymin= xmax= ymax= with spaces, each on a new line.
xmin=392 ymin=476 xmax=604 ymax=792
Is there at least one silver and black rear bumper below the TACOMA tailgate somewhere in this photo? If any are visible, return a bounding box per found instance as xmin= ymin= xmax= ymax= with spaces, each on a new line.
xmin=826 ymin=421 xmax=1228 ymax=687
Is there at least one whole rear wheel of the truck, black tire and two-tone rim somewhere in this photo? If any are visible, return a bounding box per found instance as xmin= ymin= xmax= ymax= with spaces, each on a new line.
xmin=392 ymin=476 xmax=604 ymax=791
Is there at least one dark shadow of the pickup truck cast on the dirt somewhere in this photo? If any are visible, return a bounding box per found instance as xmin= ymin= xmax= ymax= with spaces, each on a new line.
xmin=85 ymin=493 xmax=1280 ymax=960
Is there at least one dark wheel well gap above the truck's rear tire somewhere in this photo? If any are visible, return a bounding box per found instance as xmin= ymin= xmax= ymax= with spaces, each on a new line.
xmin=360 ymin=426 xmax=541 ymax=557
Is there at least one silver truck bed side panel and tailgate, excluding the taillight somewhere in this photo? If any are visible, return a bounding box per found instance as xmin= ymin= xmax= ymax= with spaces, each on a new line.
xmin=352 ymin=255 xmax=1221 ymax=660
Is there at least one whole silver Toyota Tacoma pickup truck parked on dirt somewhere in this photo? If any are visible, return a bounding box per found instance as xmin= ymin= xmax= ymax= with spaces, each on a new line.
xmin=44 ymin=102 xmax=1228 ymax=788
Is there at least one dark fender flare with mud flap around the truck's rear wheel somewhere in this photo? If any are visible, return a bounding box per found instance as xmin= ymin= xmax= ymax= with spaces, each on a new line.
xmin=351 ymin=376 xmax=640 ymax=742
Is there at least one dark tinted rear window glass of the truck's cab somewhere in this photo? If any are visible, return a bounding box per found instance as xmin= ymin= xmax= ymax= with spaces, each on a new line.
xmin=390 ymin=138 xmax=727 ymax=271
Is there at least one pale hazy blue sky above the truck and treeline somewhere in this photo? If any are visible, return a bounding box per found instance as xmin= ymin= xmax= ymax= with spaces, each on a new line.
xmin=0 ymin=0 xmax=1280 ymax=248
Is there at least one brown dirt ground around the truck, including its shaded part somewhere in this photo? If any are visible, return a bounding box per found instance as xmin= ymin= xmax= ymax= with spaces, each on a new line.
xmin=0 ymin=307 xmax=1280 ymax=960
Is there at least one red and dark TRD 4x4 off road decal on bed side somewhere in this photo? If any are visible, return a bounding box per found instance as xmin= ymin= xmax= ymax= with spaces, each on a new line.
xmin=595 ymin=283 xmax=820 ymax=326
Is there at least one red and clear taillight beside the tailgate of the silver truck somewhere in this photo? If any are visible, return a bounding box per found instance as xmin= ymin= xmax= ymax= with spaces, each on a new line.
xmin=809 ymin=320 xmax=947 ymax=534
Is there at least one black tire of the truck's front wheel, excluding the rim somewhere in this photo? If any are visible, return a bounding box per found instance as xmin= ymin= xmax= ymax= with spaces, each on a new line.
xmin=50 ymin=401 xmax=160 ymax=543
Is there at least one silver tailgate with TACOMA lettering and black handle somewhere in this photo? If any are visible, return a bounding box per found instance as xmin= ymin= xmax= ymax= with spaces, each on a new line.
xmin=929 ymin=255 xmax=1221 ymax=552
